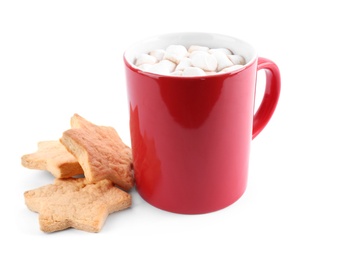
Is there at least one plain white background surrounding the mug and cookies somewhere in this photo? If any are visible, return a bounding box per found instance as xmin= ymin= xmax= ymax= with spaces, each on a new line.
xmin=0 ymin=0 xmax=338 ymax=260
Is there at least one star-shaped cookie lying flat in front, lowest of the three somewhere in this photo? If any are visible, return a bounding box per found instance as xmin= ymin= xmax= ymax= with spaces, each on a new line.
xmin=24 ymin=178 xmax=131 ymax=233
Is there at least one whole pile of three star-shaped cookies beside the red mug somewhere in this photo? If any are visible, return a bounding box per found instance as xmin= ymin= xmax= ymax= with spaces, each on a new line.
xmin=21 ymin=114 xmax=134 ymax=232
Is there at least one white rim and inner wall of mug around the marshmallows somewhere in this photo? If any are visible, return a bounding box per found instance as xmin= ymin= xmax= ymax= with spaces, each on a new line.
xmin=123 ymin=32 xmax=258 ymax=79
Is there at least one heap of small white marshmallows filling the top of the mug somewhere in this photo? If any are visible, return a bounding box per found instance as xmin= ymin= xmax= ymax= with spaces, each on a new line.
xmin=134 ymin=45 xmax=246 ymax=76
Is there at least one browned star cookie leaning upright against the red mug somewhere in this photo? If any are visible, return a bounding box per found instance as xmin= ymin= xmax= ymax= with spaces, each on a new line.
xmin=60 ymin=114 xmax=134 ymax=191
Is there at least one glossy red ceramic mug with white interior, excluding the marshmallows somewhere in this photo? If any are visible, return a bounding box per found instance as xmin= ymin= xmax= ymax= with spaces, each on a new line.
xmin=123 ymin=33 xmax=280 ymax=214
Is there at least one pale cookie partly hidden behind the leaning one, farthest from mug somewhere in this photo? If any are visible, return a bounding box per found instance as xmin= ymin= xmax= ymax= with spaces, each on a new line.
xmin=21 ymin=140 xmax=83 ymax=178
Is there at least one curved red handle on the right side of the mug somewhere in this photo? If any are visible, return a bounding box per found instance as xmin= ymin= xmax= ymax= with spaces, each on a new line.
xmin=252 ymin=57 xmax=281 ymax=139
